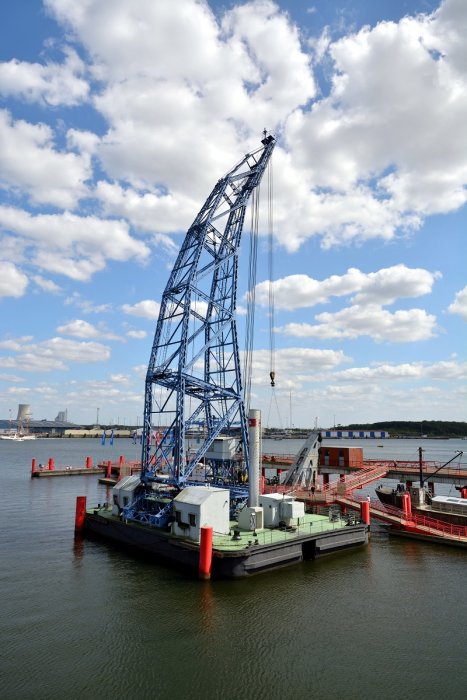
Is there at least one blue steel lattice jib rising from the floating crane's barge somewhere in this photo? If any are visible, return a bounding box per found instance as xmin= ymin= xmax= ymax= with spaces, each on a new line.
xmin=141 ymin=133 xmax=275 ymax=488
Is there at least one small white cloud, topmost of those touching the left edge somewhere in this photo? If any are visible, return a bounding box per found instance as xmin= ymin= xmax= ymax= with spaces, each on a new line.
xmin=0 ymin=47 xmax=89 ymax=107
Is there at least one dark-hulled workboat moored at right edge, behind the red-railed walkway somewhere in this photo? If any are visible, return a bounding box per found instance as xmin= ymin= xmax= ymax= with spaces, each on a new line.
xmin=376 ymin=484 xmax=467 ymax=526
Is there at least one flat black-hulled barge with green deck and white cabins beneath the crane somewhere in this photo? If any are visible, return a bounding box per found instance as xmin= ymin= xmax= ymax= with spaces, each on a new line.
xmin=84 ymin=476 xmax=368 ymax=578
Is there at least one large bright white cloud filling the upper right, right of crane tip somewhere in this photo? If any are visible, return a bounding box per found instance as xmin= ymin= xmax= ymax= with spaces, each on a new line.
xmin=285 ymin=0 xmax=467 ymax=249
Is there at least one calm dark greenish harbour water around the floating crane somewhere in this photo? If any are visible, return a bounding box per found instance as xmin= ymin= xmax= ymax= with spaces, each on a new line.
xmin=0 ymin=439 xmax=467 ymax=700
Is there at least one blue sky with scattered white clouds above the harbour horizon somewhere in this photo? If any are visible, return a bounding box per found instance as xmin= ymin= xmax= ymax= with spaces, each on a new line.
xmin=0 ymin=0 xmax=467 ymax=428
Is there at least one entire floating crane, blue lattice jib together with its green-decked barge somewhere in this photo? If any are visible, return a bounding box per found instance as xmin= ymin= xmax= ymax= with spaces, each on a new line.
xmin=82 ymin=132 xmax=368 ymax=578
